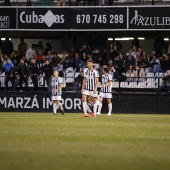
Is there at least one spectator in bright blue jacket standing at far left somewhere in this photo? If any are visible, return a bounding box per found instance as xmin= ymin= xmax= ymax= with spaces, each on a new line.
xmin=0 ymin=58 xmax=15 ymax=91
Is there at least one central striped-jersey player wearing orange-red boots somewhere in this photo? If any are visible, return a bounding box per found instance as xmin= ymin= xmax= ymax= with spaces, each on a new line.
xmin=81 ymin=59 xmax=99 ymax=118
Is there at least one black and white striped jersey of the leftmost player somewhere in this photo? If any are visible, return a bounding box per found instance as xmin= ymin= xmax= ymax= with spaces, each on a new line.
xmin=51 ymin=77 xmax=63 ymax=96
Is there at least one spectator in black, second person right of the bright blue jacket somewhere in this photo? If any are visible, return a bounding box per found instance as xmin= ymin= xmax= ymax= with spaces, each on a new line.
xmin=29 ymin=58 xmax=40 ymax=91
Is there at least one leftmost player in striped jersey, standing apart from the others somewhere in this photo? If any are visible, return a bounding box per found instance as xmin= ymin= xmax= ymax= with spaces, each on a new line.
xmin=51 ymin=70 xmax=64 ymax=115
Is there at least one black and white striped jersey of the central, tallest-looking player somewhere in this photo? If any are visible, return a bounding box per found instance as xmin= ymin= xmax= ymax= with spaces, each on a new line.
xmin=83 ymin=69 xmax=99 ymax=91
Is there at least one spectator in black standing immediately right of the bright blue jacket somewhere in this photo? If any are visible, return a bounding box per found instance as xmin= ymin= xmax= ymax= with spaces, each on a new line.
xmin=16 ymin=58 xmax=29 ymax=91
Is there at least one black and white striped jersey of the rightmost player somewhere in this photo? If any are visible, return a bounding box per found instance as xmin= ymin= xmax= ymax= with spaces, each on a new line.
xmin=100 ymin=73 xmax=113 ymax=93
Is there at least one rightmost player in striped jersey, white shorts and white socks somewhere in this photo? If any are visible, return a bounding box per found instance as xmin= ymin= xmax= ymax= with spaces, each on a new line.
xmin=97 ymin=67 xmax=113 ymax=115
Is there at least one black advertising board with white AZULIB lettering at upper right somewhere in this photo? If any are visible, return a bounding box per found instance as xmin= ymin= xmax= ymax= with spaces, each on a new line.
xmin=128 ymin=7 xmax=170 ymax=30
